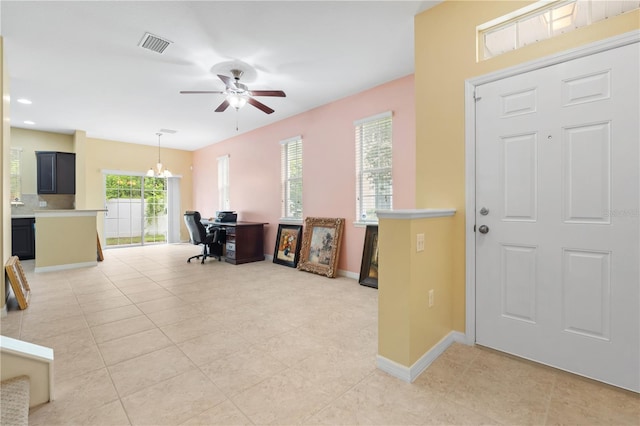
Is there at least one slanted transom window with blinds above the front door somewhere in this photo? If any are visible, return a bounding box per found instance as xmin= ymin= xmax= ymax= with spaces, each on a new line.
xmin=478 ymin=0 xmax=640 ymax=59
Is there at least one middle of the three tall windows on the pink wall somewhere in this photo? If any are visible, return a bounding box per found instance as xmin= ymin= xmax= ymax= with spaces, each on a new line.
xmin=280 ymin=136 xmax=302 ymax=220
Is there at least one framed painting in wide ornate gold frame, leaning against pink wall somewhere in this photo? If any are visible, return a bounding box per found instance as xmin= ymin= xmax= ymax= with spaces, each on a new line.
xmin=298 ymin=217 xmax=344 ymax=278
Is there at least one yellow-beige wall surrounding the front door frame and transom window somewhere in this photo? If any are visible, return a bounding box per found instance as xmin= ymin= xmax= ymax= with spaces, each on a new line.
xmin=415 ymin=1 xmax=640 ymax=331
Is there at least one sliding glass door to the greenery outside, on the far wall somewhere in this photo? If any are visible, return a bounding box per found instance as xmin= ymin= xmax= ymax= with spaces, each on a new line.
xmin=104 ymin=173 xmax=168 ymax=247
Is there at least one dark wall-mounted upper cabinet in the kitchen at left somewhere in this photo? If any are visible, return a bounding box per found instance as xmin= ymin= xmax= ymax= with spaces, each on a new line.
xmin=36 ymin=151 xmax=76 ymax=194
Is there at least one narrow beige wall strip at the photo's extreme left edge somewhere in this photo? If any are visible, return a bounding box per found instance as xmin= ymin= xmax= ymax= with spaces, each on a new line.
xmin=0 ymin=37 xmax=11 ymax=310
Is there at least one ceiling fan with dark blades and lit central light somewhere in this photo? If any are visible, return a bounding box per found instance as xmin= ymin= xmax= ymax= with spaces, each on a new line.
xmin=180 ymin=69 xmax=287 ymax=114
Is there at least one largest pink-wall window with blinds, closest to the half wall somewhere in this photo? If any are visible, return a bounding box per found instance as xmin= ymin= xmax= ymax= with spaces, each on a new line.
xmin=354 ymin=112 xmax=393 ymax=222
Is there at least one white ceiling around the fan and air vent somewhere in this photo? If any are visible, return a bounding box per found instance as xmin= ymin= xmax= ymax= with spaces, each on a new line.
xmin=0 ymin=0 xmax=439 ymax=150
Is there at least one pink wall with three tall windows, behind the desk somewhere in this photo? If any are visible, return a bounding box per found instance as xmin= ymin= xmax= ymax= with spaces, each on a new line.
xmin=193 ymin=75 xmax=416 ymax=275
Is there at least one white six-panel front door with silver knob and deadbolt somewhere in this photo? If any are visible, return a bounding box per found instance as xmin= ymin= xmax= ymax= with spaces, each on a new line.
xmin=475 ymin=43 xmax=640 ymax=391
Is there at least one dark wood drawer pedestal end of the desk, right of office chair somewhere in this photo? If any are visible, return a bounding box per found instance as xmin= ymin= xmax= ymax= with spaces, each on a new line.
xmin=225 ymin=222 xmax=264 ymax=265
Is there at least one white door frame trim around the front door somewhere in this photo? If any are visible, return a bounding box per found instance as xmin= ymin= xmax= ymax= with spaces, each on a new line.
xmin=464 ymin=30 xmax=640 ymax=345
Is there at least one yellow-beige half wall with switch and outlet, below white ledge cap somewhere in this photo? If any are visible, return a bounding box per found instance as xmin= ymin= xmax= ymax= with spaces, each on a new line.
xmin=378 ymin=217 xmax=454 ymax=367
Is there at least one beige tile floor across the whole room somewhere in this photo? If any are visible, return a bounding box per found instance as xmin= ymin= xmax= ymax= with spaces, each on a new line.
xmin=1 ymin=244 xmax=640 ymax=425
